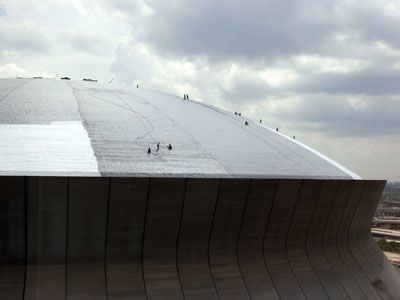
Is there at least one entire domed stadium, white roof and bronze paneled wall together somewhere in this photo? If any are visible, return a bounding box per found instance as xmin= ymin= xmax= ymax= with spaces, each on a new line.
xmin=0 ymin=78 xmax=400 ymax=300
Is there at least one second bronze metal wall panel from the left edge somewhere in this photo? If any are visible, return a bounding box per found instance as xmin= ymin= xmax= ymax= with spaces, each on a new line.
xmin=24 ymin=177 xmax=68 ymax=300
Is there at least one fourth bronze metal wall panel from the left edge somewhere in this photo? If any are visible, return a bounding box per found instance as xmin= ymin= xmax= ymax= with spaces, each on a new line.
xmin=106 ymin=178 xmax=149 ymax=300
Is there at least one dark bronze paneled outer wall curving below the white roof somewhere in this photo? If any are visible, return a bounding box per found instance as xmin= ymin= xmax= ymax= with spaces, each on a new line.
xmin=0 ymin=177 xmax=400 ymax=300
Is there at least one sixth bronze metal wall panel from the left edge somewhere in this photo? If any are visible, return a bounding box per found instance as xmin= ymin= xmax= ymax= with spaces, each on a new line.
xmin=177 ymin=179 xmax=220 ymax=300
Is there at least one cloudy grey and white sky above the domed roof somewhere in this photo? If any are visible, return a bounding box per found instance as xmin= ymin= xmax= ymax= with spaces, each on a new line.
xmin=0 ymin=0 xmax=400 ymax=180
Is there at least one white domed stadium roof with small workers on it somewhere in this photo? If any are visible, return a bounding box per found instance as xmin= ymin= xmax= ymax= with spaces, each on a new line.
xmin=0 ymin=79 xmax=359 ymax=179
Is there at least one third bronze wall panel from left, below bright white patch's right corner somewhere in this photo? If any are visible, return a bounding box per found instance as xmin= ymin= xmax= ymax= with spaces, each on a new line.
xmin=67 ymin=177 xmax=110 ymax=300
